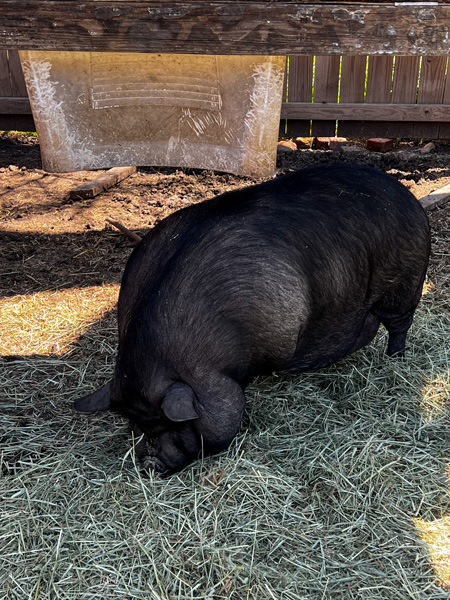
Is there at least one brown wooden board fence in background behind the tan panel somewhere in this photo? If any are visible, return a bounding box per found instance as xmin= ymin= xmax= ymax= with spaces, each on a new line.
xmin=0 ymin=50 xmax=450 ymax=139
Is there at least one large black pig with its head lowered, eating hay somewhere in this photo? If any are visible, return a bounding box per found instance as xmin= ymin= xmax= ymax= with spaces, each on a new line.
xmin=75 ymin=165 xmax=430 ymax=473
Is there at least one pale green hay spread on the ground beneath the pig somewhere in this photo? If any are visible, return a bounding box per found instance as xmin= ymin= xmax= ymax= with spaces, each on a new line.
xmin=0 ymin=224 xmax=450 ymax=600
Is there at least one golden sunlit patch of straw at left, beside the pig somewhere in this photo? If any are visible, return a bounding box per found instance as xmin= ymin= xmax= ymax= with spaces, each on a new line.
xmin=0 ymin=285 xmax=119 ymax=356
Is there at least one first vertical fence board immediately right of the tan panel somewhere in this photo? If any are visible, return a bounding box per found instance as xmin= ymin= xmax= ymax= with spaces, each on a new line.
xmin=287 ymin=56 xmax=314 ymax=137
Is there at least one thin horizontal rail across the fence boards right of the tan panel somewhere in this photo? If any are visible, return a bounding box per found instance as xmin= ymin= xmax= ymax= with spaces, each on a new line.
xmin=281 ymin=102 xmax=450 ymax=122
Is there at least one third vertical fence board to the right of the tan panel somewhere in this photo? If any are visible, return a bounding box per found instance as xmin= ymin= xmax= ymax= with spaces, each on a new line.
xmin=338 ymin=56 xmax=367 ymax=137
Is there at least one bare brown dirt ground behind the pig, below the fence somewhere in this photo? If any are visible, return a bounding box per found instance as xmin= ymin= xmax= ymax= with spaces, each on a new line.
xmin=0 ymin=133 xmax=450 ymax=308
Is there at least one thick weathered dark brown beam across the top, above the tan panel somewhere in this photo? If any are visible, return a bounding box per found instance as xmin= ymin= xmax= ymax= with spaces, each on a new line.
xmin=0 ymin=0 xmax=450 ymax=56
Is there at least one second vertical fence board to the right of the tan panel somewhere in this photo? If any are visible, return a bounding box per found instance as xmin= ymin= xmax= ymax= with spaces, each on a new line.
xmin=311 ymin=56 xmax=341 ymax=136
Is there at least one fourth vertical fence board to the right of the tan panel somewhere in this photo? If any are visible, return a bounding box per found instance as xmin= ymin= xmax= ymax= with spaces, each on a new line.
xmin=363 ymin=56 xmax=394 ymax=138
